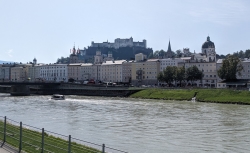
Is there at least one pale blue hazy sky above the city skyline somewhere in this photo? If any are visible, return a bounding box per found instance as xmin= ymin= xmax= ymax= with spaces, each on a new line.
xmin=0 ymin=0 xmax=250 ymax=63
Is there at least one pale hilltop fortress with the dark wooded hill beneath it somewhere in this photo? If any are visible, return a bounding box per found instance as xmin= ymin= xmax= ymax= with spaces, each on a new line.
xmin=64 ymin=37 xmax=153 ymax=63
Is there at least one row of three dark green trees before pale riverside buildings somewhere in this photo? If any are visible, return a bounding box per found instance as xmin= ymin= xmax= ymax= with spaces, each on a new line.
xmin=157 ymin=66 xmax=204 ymax=86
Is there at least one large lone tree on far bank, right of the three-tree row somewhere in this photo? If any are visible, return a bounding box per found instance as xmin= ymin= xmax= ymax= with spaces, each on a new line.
xmin=217 ymin=55 xmax=243 ymax=81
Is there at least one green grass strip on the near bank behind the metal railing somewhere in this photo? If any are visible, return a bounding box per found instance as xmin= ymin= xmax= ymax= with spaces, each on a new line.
xmin=0 ymin=121 xmax=101 ymax=153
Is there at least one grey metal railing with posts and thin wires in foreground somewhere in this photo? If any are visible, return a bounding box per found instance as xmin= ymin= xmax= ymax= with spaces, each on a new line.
xmin=0 ymin=116 xmax=127 ymax=153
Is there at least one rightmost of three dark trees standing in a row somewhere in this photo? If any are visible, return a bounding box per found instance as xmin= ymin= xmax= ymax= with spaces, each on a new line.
xmin=186 ymin=65 xmax=204 ymax=85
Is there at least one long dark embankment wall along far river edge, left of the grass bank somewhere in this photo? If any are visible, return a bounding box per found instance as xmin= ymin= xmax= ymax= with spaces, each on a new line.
xmin=0 ymin=83 xmax=142 ymax=97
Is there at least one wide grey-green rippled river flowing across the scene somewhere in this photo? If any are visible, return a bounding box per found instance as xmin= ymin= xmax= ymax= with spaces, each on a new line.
xmin=0 ymin=94 xmax=250 ymax=153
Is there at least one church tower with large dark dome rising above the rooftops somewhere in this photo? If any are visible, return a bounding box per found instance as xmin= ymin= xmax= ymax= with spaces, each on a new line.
xmin=201 ymin=36 xmax=216 ymax=62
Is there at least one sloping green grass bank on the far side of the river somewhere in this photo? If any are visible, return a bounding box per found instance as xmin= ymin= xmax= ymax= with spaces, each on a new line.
xmin=130 ymin=89 xmax=250 ymax=105
